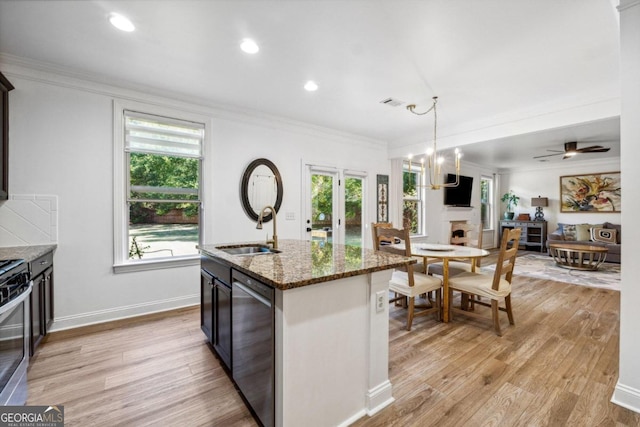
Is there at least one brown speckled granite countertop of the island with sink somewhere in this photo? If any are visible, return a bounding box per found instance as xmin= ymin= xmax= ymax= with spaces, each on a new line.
xmin=198 ymin=240 xmax=416 ymax=290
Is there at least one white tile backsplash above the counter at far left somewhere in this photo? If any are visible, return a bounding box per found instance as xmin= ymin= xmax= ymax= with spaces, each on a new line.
xmin=0 ymin=194 xmax=58 ymax=247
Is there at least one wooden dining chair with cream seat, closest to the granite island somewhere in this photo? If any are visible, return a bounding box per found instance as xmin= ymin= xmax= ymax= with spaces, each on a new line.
xmin=371 ymin=224 xmax=442 ymax=331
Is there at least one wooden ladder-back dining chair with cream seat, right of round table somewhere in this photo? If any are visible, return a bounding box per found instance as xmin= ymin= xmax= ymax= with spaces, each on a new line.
xmin=449 ymin=228 xmax=522 ymax=336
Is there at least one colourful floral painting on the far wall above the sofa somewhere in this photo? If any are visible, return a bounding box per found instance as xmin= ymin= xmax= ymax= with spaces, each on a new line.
xmin=560 ymin=171 xmax=622 ymax=213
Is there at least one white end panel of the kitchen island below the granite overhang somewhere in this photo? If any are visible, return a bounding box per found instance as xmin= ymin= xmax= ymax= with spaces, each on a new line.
xmin=276 ymin=270 xmax=393 ymax=427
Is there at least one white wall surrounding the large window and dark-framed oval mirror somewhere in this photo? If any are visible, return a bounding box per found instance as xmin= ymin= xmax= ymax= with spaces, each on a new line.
xmin=0 ymin=63 xmax=389 ymax=330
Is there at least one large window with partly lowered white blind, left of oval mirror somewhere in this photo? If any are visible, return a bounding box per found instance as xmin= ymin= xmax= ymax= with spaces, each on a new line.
xmin=115 ymin=103 xmax=205 ymax=271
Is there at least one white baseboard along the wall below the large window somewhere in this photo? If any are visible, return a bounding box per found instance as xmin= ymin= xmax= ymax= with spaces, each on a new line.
xmin=51 ymin=294 xmax=200 ymax=332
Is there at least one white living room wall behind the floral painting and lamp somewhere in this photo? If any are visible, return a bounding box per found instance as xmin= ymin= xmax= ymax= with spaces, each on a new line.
xmin=498 ymin=159 xmax=629 ymax=234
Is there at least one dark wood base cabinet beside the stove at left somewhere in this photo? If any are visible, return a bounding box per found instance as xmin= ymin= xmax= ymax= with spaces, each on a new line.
xmin=29 ymin=252 xmax=54 ymax=356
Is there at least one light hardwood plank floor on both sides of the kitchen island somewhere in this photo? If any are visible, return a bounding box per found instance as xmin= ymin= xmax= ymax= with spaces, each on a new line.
xmin=27 ymin=264 xmax=640 ymax=426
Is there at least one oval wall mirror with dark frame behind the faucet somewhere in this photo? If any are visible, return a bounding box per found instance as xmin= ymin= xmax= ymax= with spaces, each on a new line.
xmin=240 ymin=159 xmax=282 ymax=222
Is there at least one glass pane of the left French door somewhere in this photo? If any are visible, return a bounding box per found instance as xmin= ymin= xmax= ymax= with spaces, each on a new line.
xmin=311 ymin=174 xmax=333 ymax=243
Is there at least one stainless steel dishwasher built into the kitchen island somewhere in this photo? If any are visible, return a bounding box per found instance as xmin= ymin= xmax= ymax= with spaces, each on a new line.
xmin=231 ymin=270 xmax=275 ymax=427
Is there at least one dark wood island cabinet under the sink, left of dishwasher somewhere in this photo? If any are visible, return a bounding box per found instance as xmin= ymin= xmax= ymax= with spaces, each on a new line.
xmin=200 ymin=256 xmax=232 ymax=369
